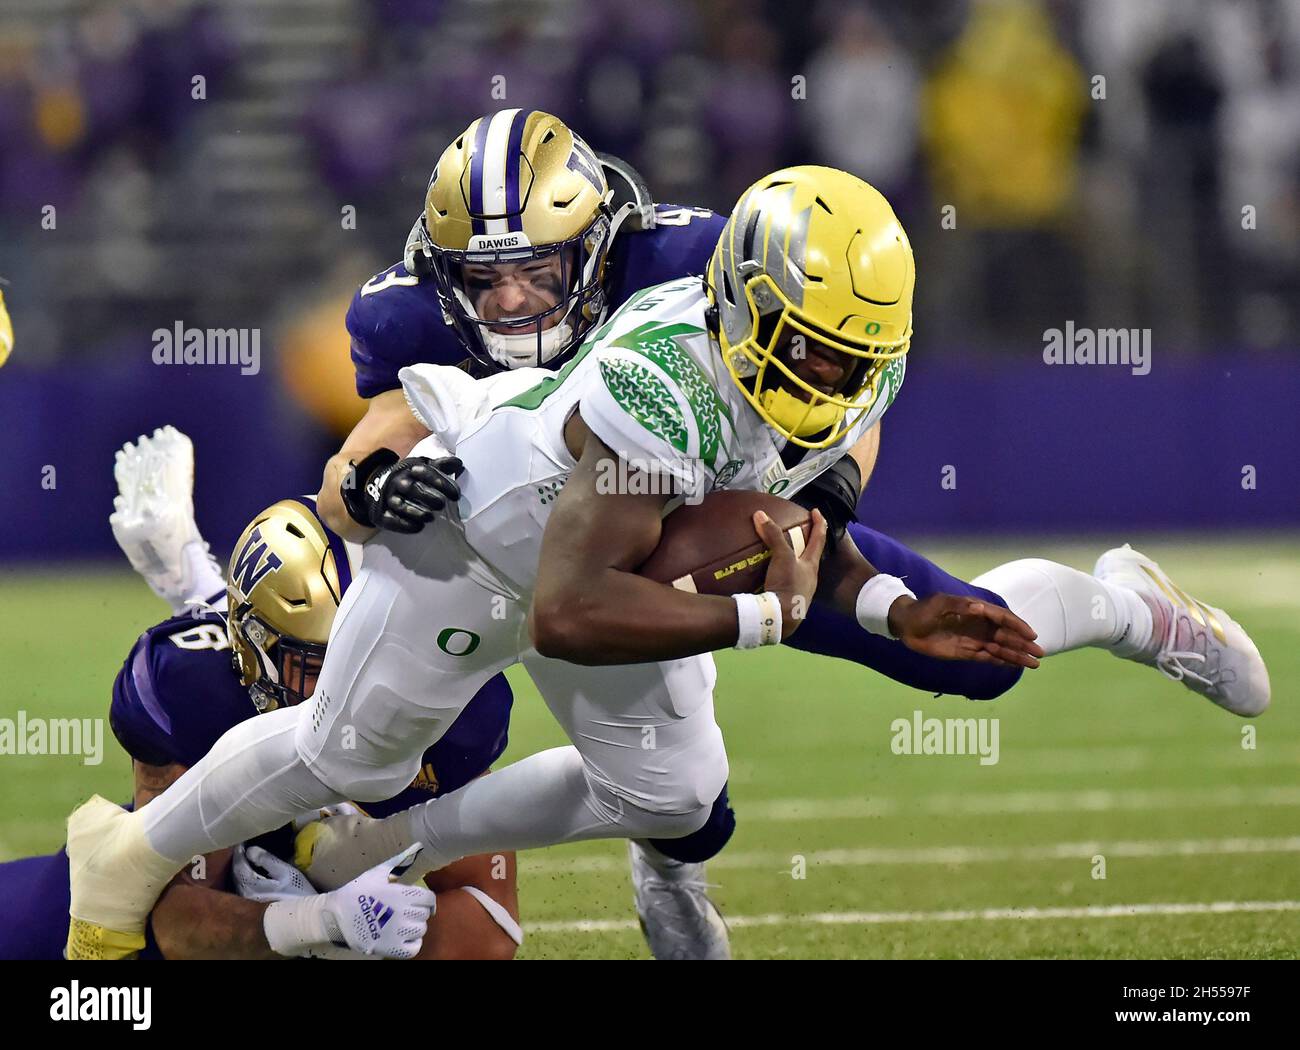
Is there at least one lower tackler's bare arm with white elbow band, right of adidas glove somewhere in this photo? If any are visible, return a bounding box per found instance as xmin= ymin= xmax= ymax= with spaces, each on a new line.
xmin=415 ymin=852 xmax=523 ymax=960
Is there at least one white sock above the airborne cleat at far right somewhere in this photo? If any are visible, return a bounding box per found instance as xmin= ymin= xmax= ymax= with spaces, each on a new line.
xmin=971 ymin=557 xmax=1152 ymax=656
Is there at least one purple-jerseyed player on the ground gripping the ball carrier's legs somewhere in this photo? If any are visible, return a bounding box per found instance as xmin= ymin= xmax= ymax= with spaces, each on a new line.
xmin=0 ymin=428 xmax=523 ymax=959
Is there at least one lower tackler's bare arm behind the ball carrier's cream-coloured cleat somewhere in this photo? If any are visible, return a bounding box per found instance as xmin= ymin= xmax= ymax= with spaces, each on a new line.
xmin=131 ymin=760 xmax=283 ymax=959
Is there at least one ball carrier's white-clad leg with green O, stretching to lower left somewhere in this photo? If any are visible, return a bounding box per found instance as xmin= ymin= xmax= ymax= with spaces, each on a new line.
xmin=68 ymin=528 xmax=523 ymax=956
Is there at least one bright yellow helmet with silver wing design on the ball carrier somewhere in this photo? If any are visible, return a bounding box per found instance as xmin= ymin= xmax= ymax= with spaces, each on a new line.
xmin=709 ymin=165 xmax=917 ymax=448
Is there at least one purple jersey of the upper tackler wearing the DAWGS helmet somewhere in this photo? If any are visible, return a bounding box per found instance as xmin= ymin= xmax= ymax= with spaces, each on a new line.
xmin=347 ymin=204 xmax=727 ymax=398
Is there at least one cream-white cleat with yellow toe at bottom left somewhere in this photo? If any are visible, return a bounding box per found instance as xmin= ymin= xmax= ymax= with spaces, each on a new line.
xmin=64 ymin=795 xmax=178 ymax=959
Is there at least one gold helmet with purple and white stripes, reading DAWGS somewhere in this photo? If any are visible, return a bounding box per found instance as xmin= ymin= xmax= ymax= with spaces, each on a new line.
xmin=407 ymin=109 xmax=621 ymax=370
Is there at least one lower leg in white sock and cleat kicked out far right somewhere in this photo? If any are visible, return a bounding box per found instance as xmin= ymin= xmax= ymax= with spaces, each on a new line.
xmin=975 ymin=544 xmax=1270 ymax=717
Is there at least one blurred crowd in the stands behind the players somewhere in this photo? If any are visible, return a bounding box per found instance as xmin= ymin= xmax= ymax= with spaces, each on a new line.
xmin=0 ymin=0 xmax=1300 ymax=558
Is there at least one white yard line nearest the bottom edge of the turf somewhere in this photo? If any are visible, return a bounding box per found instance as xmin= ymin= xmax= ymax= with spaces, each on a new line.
xmin=525 ymin=901 xmax=1300 ymax=933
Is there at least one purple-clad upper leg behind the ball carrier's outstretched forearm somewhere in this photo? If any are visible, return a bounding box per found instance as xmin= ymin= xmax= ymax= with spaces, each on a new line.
xmin=787 ymin=521 xmax=1032 ymax=700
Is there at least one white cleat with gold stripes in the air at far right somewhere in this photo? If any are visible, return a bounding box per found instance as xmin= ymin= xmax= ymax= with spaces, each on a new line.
xmin=1093 ymin=543 xmax=1270 ymax=719
